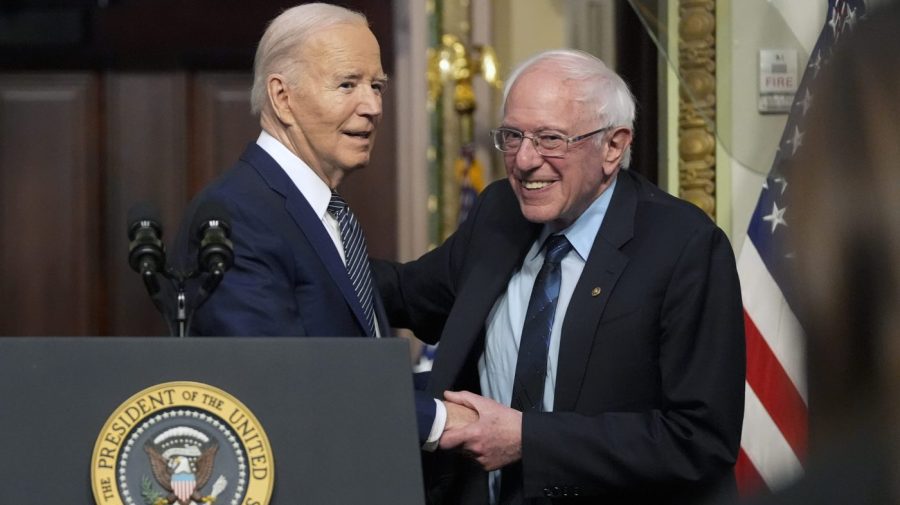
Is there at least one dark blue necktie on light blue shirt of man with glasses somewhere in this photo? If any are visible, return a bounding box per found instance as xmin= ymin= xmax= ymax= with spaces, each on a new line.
xmin=498 ymin=235 xmax=572 ymax=505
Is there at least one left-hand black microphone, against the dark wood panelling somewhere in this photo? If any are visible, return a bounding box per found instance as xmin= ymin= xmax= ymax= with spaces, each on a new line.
xmin=127 ymin=202 xmax=166 ymax=295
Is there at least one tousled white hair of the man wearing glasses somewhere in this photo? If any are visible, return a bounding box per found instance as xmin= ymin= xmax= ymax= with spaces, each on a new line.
xmin=501 ymin=49 xmax=635 ymax=168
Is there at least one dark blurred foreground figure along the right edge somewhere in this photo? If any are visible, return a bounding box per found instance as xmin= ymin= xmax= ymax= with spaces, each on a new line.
xmin=762 ymin=4 xmax=900 ymax=504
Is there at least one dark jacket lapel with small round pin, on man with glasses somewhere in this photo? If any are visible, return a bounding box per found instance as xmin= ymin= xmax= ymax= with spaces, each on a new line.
xmin=553 ymin=172 xmax=637 ymax=411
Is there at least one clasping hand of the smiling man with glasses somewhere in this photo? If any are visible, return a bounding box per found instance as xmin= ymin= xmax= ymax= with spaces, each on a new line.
xmin=440 ymin=391 xmax=522 ymax=471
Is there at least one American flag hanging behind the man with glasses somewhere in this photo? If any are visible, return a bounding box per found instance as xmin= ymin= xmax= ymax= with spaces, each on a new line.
xmin=736 ymin=0 xmax=865 ymax=495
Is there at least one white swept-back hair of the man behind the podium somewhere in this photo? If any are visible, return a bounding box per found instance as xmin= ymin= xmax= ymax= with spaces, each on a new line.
xmin=250 ymin=3 xmax=369 ymax=115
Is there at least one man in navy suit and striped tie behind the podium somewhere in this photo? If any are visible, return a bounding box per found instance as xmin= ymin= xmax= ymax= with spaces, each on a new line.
xmin=177 ymin=3 xmax=473 ymax=445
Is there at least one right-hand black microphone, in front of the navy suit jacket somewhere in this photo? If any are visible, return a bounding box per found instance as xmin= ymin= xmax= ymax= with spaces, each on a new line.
xmin=191 ymin=200 xmax=234 ymax=276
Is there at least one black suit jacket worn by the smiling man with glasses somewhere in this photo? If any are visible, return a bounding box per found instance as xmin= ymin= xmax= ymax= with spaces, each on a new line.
xmin=376 ymin=171 xmax=745 ymax=504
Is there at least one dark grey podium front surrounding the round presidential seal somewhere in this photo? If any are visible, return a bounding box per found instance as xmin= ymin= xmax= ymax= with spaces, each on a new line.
xmin=0 ymin=337 xmax=424 ymax=505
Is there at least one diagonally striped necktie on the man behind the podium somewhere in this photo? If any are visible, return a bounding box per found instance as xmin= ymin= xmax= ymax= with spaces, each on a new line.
xmin=328 ymin=191 xmax=376 ymax=337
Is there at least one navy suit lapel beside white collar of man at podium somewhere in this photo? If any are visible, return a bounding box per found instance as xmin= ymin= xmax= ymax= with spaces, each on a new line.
xmin=241 ymin=143 xmax=372 ymax=337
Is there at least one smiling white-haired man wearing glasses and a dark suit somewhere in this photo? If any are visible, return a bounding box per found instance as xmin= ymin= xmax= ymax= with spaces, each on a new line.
xmin=376 ymin=50 xmax=744 ymax=505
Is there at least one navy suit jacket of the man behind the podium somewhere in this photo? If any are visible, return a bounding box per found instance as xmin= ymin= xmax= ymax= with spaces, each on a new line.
xmin=175 ymin=143 xmax=435 ymax=441
